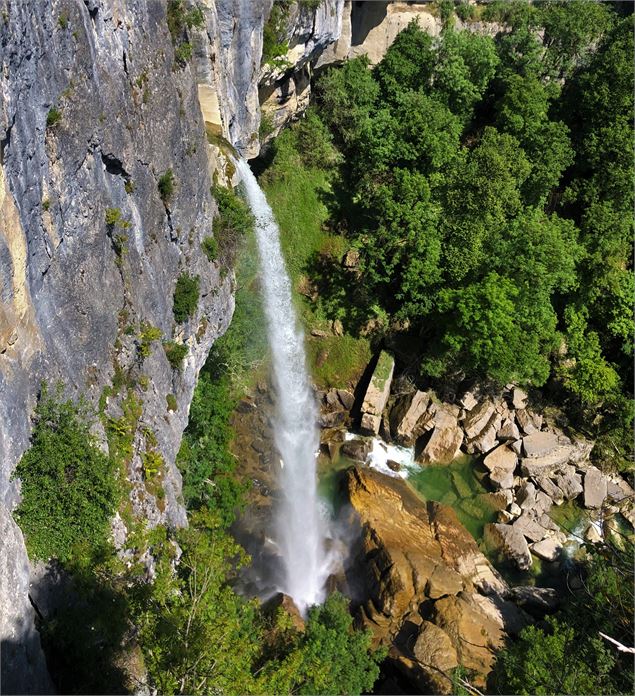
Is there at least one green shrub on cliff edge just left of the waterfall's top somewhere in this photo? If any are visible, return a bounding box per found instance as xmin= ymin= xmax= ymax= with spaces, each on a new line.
xmin=212 ymin=186 xmax=254 ymax=268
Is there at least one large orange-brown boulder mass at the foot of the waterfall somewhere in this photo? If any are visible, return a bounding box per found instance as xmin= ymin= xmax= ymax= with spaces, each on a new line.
xmin=345 ymin=467 xmax=525 ymax=693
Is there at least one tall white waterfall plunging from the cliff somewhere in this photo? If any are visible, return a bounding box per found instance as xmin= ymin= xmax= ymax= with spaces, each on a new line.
xmin=238 ymin=160 xmax=329 ymax=613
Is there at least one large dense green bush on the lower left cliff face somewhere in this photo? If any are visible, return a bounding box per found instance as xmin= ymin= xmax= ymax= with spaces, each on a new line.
xmin=15 ymin=385 xmax=118 ymax=561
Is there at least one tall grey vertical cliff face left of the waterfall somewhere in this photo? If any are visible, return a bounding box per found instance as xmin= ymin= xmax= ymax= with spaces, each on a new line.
xmin=0 ymin=0 xmax=234 ymax=693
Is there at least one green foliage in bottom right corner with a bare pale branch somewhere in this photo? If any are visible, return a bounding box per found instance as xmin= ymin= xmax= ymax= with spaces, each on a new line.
xmin=492 ymin=546 xmax=633 ymax=694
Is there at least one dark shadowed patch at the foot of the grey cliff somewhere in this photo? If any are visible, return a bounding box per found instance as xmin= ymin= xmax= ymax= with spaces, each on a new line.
xmin=29 ymin=563 xmax=136 ymax=694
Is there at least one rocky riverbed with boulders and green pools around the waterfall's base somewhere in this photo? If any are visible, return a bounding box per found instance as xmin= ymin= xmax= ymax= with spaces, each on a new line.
xmin=226 ymin=353 xmax=634 ymax=693
